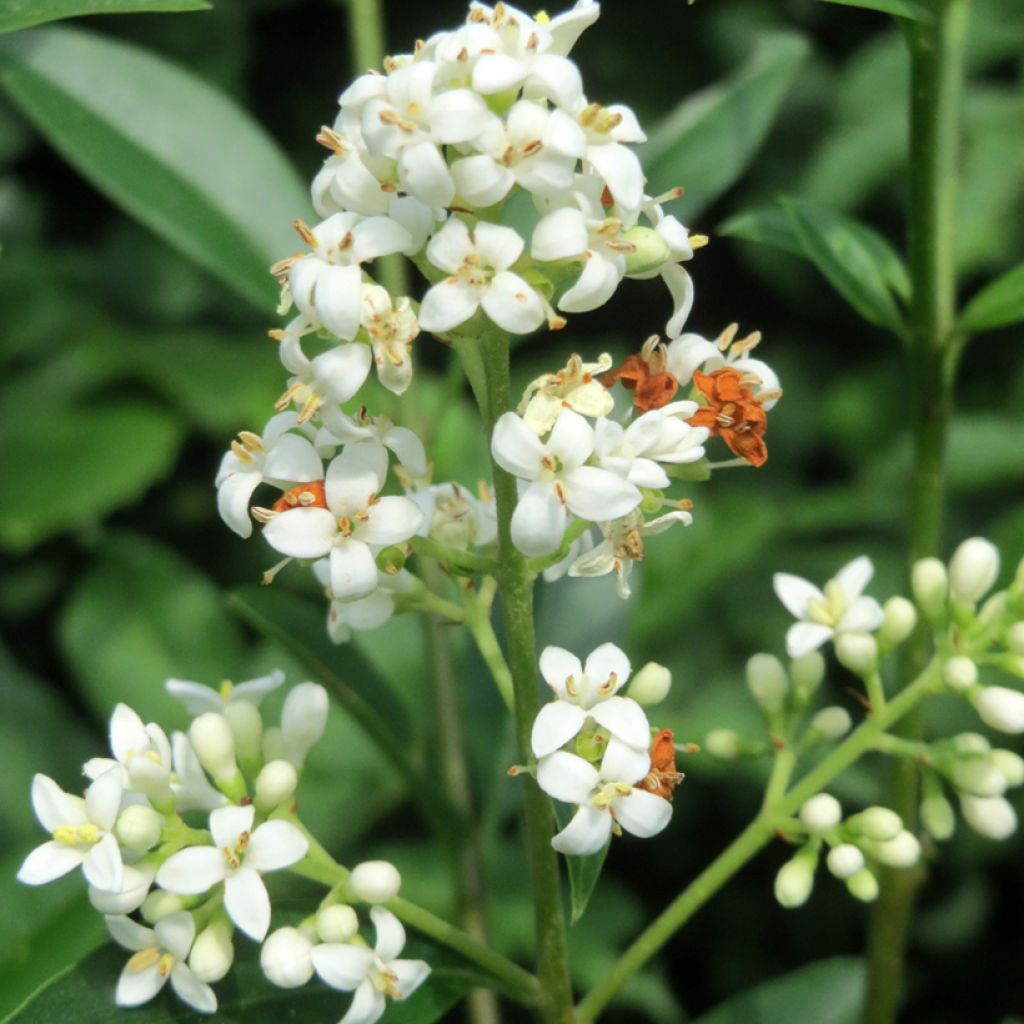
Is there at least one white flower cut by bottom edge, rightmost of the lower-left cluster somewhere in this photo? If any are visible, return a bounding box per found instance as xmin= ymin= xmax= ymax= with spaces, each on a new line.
xmin=312 ymin=906 xmax=430 ymax=1024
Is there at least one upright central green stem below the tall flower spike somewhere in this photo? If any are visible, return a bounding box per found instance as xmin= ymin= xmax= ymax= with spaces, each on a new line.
xmin=479 ymin=331 xmax=574 ymax=1024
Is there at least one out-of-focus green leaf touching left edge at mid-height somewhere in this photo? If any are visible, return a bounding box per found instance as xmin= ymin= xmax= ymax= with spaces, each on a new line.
xmin=0 ymin=401 xmax=181 ymax=551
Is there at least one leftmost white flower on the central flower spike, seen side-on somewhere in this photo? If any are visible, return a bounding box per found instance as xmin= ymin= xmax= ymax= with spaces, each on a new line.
xmin=216 ymin=412 xmax=324 ymax=537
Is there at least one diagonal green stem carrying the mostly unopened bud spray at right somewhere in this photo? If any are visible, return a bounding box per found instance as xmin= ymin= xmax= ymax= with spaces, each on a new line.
xmin=577 ymin=659 xmax=941 ymax=1024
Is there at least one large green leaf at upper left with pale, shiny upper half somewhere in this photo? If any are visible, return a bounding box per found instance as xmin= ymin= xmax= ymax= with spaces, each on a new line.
xmin=0 ymin=28 xmax=309 ymax=309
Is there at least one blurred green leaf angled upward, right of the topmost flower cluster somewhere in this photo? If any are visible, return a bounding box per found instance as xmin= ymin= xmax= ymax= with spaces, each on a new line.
xmin=640 ymin=33 xmax=809 ymax=222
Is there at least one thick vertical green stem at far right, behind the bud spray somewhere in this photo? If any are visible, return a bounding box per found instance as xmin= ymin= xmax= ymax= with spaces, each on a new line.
xmin=863 ymin=0 xmax=969 ymax=1024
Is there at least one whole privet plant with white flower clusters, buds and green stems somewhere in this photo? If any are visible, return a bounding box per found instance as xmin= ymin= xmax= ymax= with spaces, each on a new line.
xmin=8 ymin=0 xmax=1024 ymax=1024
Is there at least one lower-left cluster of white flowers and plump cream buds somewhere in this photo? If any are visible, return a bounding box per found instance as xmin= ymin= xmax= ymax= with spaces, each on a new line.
xmin=17 ymin=672 xmax=429 ymax=1024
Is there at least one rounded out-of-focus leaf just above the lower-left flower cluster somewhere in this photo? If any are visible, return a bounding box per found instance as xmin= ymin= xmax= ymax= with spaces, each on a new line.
xmin=60 ymin=534 xmax=242 ymax=722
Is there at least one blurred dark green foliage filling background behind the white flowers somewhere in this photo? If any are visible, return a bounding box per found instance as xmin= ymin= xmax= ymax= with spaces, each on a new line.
xmin=0 ymin=0 xmax=1024 ymax=1024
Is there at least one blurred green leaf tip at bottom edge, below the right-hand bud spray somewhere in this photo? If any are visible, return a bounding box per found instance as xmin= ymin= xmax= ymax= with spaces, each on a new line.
xmin=693 ymin=956 xmax=864 ymax=1024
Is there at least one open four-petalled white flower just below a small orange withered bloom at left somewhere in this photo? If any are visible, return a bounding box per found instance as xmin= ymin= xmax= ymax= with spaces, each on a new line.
xmin=263 ymin=444 xmax=422 ymax=600
